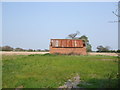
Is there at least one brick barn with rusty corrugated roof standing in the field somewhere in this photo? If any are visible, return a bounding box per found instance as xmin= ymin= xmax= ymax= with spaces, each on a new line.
xmin=50 ymin=39 xmax=87 ymax=55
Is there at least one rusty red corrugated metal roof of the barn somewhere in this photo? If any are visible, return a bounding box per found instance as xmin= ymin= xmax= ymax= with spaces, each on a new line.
xmin=51 ymin=39 xmax=84 ymax=47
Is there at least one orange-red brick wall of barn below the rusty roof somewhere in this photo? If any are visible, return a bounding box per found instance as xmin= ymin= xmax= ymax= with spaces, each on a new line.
xmin=50 ymin=46 xmax=87 ymax=55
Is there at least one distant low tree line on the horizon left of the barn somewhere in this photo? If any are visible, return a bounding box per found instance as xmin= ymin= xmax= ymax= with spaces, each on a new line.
xmin=0 ymin=46 xmax=49 ymax=52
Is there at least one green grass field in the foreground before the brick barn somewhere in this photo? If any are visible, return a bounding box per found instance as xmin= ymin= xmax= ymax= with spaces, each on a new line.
xmin=2 ymin=54 xmax=118 ymax=88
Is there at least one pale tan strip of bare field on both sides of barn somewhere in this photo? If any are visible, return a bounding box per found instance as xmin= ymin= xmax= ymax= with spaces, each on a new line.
xmin=0 ymin=51 xmax=120 ymax=56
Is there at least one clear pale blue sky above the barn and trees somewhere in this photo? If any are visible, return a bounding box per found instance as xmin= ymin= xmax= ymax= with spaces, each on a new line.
xmin=0 ymin=2 xmax=118 ymax=50
